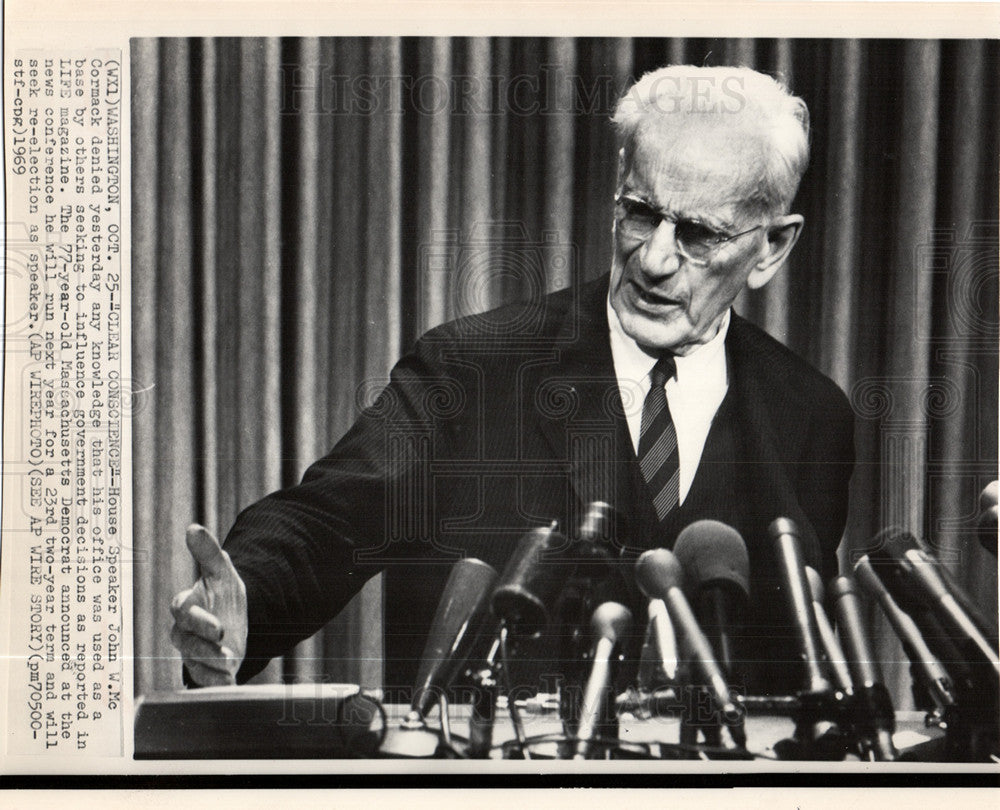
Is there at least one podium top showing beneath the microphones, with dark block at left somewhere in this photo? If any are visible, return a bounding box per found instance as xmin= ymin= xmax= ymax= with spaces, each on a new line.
xmin=135 ymin=684 xmax=941 ymax=769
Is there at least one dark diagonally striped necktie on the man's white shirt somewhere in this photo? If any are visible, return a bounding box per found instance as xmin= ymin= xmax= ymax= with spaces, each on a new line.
xmin=637 ymin=356 xmax=680 ymax=523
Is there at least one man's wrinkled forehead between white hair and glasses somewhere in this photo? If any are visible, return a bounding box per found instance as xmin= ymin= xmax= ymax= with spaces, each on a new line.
xmin=622 ymin=113 xmax=767 ymax=211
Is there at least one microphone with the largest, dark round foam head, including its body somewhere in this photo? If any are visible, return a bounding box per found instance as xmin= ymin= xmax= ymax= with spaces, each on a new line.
xmin=674 ymin=520 xmax=750 ymax=677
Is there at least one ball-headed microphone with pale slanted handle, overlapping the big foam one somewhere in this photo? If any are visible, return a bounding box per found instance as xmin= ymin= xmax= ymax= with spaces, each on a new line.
xmin=635 ymin=548 xmax=746 ymax=747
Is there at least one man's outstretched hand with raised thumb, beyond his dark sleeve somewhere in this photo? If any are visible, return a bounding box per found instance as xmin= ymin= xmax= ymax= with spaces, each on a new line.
xmin=170 ymin=523 xmax=247 ymax=686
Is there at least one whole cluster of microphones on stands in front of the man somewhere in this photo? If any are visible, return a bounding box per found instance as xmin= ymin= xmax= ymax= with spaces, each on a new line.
xmin=386 ymin=482 xmax=1000 ymax=762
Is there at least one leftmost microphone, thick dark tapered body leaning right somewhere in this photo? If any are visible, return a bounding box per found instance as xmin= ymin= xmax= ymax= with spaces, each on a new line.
xmin=404 ymin=558 xmax=497 ymax=727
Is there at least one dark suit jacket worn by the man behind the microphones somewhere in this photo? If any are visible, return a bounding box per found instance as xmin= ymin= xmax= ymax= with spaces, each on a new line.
xmin=225 ymin=276 xmax=854 ymax=688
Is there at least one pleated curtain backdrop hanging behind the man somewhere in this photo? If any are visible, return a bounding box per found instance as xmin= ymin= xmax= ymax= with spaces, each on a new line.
xmin=132 ymin=38 xmax=998 ymax=706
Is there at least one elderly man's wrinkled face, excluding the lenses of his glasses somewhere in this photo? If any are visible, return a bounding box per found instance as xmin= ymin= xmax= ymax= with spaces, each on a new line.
xmin=611 ymin=121 xmax=766 ymax=355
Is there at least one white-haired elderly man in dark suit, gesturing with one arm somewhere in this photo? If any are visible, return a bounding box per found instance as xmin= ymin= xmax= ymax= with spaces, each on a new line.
xmin=173 ymin=66 xmax=854 ymax=691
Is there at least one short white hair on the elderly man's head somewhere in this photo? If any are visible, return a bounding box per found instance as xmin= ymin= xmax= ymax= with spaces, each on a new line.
xmin=613 ymin=65 xmax=809 ymax=215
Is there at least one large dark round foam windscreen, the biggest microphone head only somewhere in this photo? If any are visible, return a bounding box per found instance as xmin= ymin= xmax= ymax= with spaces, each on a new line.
xmin=674 ymin=520 xmax=750 ymax=595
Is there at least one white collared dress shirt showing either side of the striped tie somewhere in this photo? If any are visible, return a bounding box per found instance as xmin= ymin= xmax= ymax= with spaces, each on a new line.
xmin=607 ymin=301 xmax=729 ymax=503
